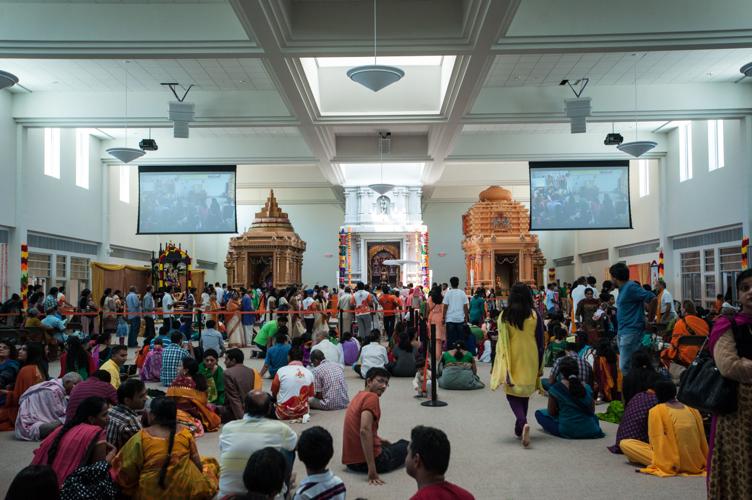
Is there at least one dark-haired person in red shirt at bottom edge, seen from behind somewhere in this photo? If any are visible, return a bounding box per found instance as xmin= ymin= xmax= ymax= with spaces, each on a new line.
xmin=405 ymin=425 xmax=475 ymax=500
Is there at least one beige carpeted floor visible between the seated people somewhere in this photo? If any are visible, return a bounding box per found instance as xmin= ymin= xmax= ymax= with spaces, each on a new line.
xmin=0 ymin=353 xmax=705 ymax=500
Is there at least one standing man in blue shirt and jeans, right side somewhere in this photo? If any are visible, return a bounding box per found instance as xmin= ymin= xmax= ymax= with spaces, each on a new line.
xmin=608 ymin=262 xmax=655 ymax=376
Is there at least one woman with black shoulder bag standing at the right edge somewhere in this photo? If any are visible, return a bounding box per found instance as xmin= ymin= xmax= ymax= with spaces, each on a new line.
xmin=708 ymin=269 xmax=752 ymax=499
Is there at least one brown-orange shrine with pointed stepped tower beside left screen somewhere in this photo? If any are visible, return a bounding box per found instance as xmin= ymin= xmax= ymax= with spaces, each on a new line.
xmin=225 ymin=190 xmax=306 ymax=288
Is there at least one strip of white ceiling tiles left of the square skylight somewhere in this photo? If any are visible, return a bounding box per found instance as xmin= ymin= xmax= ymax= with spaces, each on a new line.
xmin=0 ymin=59 xmax=275 ymax=93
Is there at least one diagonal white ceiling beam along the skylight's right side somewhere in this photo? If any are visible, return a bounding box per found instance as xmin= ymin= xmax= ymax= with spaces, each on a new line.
xmin=422 ymin=0 xmax=520 ymax=184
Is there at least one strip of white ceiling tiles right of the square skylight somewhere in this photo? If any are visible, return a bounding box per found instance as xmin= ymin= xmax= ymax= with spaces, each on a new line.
xmin=485 ymin=49 xmax=752 ymax=87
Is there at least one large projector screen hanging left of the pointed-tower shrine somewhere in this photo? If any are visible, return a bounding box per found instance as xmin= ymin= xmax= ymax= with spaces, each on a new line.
xmin=138 ymin=165 xmax=237 ymax=234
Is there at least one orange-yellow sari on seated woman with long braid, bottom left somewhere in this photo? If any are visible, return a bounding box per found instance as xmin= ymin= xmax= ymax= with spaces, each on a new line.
xmin=112 ymin=428 xmax=219 ymax=500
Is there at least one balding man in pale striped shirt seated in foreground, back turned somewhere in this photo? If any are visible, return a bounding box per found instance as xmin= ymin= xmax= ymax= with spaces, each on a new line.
xmin=219 ymin=391 xmax=298 ymax=498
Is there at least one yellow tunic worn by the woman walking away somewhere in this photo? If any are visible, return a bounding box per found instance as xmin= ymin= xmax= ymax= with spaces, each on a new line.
xmin=491 ymin=311 xmax=543 ymax=397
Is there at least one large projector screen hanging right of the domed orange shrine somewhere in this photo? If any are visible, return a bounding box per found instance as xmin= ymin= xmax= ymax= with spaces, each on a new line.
xmin=530 ymin=160 xmax=632 ymax=231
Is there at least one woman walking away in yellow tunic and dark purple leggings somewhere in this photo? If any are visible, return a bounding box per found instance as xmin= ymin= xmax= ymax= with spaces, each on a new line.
xmin=491 ymin=283 xmax=543 ymax=448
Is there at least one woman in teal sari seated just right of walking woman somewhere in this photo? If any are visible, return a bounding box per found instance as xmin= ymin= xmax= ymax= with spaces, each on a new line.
xmin=535 ymin=356 xmax=605 ymax=439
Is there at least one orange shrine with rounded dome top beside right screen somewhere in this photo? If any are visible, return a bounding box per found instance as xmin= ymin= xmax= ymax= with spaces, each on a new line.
xmin=462 ymin=186 xmax=546 ymax=295
